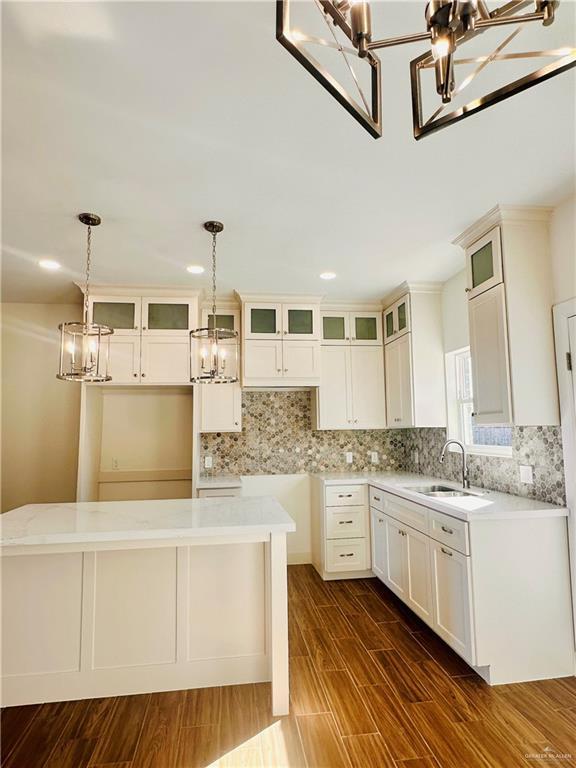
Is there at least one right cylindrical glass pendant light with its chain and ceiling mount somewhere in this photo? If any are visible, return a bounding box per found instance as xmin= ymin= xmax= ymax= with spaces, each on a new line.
xmin=190 ymin=221 xmax=239 ymax=384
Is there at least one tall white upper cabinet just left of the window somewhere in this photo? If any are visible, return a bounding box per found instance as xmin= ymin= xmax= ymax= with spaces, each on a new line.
xmin=384 ymin=283 xmax=446 ymax=429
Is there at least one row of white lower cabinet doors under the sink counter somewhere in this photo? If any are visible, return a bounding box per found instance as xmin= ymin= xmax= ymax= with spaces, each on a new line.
xmin=371 ymin=494 xmax=474 ymax=664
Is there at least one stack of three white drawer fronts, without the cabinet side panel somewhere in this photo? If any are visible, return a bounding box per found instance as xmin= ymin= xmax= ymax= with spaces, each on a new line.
xmin=324 ymin=485 xmax=370 ymax=573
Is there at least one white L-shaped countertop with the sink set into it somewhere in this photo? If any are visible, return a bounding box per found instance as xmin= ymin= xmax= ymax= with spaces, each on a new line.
xmin=313 ymin=472 xmax=568 ymax=521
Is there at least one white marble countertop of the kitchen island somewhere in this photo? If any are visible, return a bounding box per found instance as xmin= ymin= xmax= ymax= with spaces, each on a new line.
xmin=0 ymin=496 xmax=296 ymax=552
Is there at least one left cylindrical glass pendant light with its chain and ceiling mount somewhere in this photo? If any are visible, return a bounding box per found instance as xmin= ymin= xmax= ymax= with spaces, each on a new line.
xmin=57 ymin=213 xmax=114 ymax=382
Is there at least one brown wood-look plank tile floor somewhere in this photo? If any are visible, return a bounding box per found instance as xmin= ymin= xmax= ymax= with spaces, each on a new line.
xmin=1 ymin=566 xmax=576 ymax=768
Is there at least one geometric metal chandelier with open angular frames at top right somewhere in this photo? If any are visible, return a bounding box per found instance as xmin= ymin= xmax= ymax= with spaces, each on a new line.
xmin=276 ymin=0 xmax=576 ymax=139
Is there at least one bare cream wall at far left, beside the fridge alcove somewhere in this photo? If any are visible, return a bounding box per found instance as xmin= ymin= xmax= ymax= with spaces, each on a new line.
xmin=1 ymin=303 xmax=81 ymax=511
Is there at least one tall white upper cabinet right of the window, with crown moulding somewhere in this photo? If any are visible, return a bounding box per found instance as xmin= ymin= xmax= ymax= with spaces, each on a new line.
xmin=454 ymin=206 xmax=559 ymax=426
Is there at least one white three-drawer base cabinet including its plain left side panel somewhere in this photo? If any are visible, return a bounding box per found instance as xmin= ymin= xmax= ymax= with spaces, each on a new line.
xmin=312 ymin=479 xmax=372 ymax=579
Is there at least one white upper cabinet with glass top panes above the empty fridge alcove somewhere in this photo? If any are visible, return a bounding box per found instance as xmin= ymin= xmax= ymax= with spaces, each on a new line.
xmin=89 ymin=294 xmax=198 ymax=386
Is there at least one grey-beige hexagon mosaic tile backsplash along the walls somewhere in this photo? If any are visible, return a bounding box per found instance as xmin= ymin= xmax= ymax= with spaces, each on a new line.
xmin=200 ymin=391 xmax=566 ymax=504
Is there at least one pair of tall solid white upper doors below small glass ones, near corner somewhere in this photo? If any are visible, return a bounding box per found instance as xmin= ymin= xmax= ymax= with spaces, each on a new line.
xmin=314 ymin=345 xmax=386 ymax=429
